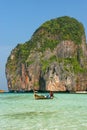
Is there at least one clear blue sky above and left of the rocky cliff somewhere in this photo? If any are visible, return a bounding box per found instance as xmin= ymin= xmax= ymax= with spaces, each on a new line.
xmin=0 ymin=0 xmax=87 ymax=91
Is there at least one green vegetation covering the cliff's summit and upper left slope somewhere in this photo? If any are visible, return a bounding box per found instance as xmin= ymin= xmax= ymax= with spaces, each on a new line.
xmin=7 ymin=16 xmax=85 ymax=62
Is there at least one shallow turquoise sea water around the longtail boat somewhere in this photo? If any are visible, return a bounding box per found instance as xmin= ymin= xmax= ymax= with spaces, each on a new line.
xmin=0 ymin=93 xmax=87 ymax=130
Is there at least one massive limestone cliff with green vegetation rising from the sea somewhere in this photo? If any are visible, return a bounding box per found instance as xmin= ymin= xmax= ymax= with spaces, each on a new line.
xmin=6 ymin=17 xmax=87 ymax=91
